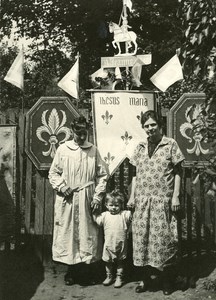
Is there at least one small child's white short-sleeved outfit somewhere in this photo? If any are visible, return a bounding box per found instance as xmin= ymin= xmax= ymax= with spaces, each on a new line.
xmin=94 ymin=210 xmax=131 ymax=262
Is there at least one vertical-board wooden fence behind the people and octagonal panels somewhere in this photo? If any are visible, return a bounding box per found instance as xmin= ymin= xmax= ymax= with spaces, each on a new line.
xmin=0 ymin=109 xmax=216 ymax=264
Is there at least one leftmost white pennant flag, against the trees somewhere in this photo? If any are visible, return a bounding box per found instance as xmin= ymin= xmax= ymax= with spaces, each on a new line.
xmin=4 ymin=49 xmax=24 ymax=90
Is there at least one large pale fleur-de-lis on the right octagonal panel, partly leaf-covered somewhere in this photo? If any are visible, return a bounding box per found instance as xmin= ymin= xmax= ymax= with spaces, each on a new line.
xmin=180 ymin=104 xmax=209 ymax=156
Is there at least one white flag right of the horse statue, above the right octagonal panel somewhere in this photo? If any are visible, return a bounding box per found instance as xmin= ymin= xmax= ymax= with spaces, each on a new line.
xmin=150 ymin=54 xmax=184 ymax=92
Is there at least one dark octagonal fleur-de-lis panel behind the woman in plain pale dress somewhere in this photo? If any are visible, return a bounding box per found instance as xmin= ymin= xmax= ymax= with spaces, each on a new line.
xmin=25 ymin=97 xmax=80 ymax=170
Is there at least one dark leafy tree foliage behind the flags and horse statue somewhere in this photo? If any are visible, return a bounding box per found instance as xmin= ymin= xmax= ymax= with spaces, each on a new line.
xmin=0 ymin=0 xmax=216 ymax=150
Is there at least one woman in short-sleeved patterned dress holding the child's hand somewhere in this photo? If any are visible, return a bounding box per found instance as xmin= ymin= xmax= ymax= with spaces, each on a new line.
xmin=128 ymin=111 xmax=184 ymax=295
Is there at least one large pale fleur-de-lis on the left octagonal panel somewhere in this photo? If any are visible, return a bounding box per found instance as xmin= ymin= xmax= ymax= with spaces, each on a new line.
xmin=36 ymin=108 xmax=71 ymax=158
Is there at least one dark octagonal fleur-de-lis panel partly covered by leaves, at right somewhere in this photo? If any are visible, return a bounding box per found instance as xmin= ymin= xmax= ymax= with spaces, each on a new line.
xmin=167 ymin=93 xmax=210 ymax=167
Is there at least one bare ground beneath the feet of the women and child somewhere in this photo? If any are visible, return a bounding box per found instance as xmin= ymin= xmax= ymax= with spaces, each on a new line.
xmin=0 ymin=247 xmax=216 ymax=300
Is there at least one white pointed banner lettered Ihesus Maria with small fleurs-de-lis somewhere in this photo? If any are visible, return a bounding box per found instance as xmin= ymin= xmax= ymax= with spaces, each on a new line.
xmin=93 ymin=91 xmax=154 ymax=174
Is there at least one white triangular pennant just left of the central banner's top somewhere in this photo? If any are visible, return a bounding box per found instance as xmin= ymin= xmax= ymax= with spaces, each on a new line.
xmin=58 ymin=57 xmax=79 ymax=99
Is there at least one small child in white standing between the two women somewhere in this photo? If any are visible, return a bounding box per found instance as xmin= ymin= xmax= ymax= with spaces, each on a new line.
xmin=93 ymin=191 xmax=132 ymax=288
